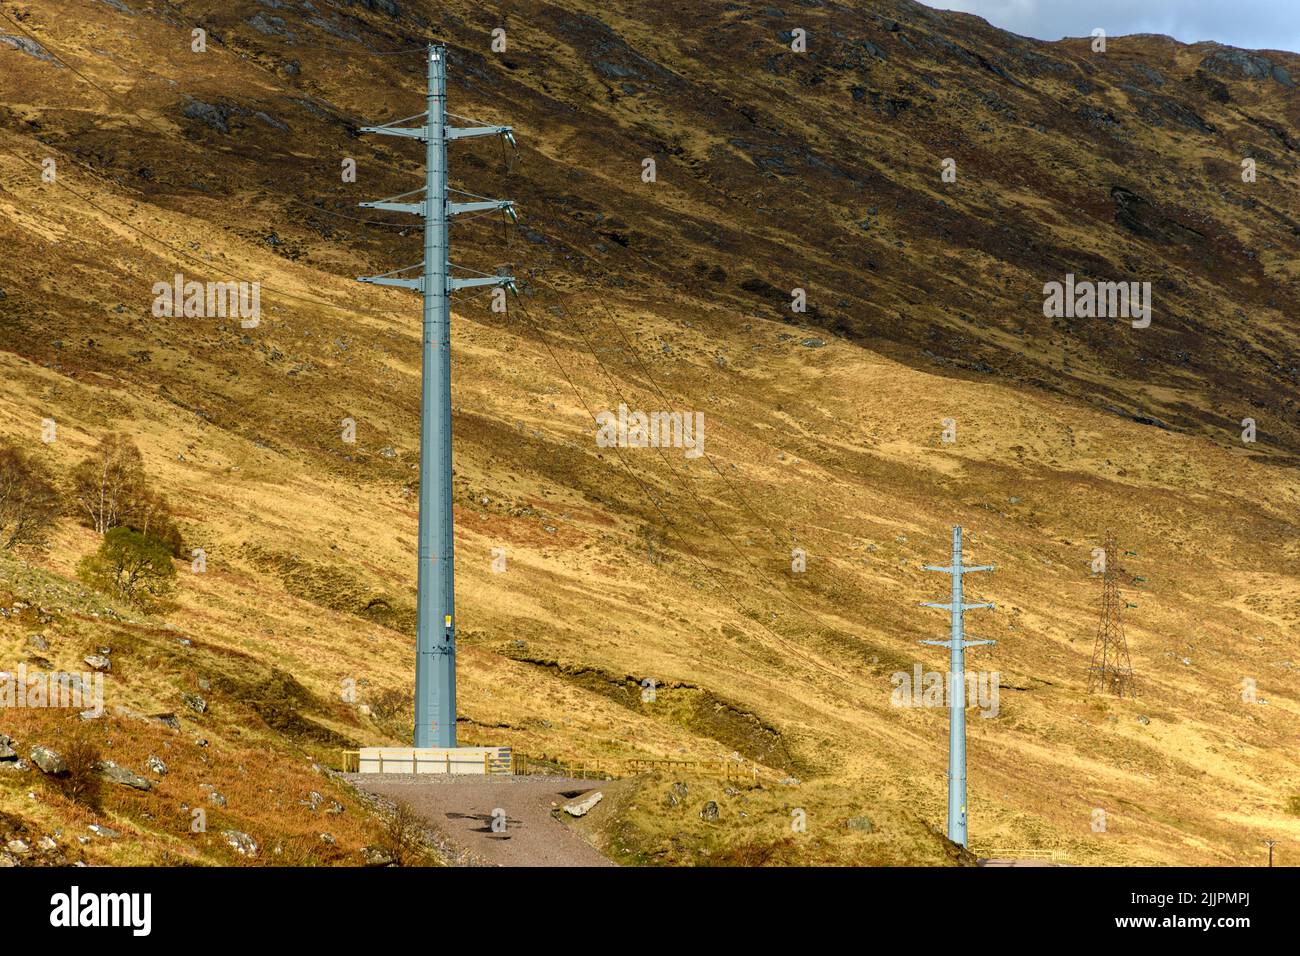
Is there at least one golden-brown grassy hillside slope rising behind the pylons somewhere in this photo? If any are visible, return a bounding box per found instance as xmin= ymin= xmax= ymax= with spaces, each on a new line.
xmin=0 ymin=0 xmax=1300 ymax=864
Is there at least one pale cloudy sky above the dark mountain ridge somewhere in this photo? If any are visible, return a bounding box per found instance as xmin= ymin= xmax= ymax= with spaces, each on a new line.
xmin=924 ymin=0 xmax=1300 ymax=53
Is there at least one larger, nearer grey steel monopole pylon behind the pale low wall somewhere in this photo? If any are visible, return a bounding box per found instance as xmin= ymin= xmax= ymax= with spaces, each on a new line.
xmin=359 ymin=44 xmax=515 ymax=747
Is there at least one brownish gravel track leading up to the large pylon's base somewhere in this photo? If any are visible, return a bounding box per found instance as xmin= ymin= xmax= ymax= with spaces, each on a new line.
xmin=347 ymin=774 xmax=614 ymax=866
